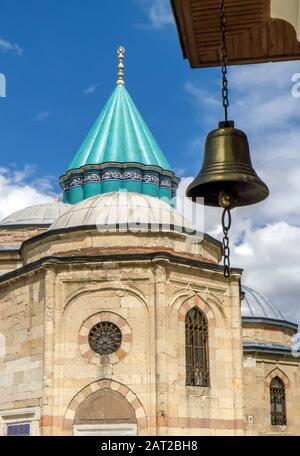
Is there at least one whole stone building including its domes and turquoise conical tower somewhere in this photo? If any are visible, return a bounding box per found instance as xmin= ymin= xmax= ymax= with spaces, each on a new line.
xmin=0 ymin=58 xmax=300 ymax=435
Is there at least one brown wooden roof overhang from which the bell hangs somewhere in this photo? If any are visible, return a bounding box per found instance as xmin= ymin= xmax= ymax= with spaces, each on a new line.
xmin=171 ymin=0 xmax=300 ymax=68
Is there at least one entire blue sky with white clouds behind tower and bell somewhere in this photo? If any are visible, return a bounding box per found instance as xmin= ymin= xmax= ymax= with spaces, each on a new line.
xmin=0 ymin=0 xmax=300 ymax=322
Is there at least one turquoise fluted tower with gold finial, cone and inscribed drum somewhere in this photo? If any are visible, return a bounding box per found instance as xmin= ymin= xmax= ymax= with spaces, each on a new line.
xmin=60 ymin=48 xmax=179 ymax=204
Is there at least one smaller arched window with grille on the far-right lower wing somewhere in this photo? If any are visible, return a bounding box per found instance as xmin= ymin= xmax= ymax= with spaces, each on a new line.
xmin=270 ymin=377 xmax=286 ymax=426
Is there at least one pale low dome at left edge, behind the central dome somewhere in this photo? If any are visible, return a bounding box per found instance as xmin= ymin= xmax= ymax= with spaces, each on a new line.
xmin=0 ymin=201 xmax=72 ymax=227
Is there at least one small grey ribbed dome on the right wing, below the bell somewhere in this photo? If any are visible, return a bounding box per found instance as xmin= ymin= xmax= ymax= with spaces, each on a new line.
xmin=241 ymin=285 xmax=286 ymax=321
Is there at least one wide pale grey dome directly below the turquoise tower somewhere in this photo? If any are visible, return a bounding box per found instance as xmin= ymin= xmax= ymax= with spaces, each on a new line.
xmin=49 ymin=191 xmax=195 ymax=234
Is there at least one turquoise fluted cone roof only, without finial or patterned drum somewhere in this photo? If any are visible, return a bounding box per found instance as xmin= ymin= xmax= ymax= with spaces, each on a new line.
xmin=68 ymin=84 xmax=171 ymax=171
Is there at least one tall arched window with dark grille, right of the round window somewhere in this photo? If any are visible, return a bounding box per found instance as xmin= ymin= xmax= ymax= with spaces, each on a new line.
xmin=185 ymin=307 xmax=209 ymax=386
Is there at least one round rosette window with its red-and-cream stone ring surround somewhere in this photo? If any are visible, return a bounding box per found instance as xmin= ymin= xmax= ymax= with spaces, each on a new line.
xmin=78 ymin=312 xmax=132 ymax=365
